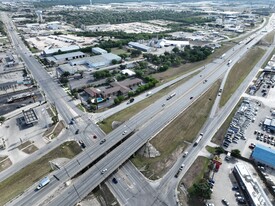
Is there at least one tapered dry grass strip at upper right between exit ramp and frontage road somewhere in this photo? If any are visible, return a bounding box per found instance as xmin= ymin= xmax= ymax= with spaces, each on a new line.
xmin=220 ymin=46 xmax=266 ymax=107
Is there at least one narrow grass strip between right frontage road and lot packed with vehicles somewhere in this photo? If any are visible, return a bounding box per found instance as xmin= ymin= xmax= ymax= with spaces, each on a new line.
xmin=211 ymin=99 xmax=242 ymax=145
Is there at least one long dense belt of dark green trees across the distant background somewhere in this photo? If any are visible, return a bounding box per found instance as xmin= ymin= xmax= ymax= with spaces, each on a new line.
xmin=49 ymin=10 xmax=213 ymax=28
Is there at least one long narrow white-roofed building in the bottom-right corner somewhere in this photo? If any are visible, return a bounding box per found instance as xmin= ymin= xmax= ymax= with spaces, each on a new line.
xmin=233 ymin=163 xmax=272 ymax=206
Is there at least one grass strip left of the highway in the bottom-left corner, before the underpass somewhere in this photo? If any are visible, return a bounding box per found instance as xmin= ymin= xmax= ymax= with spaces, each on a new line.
xmin=0 ymin=141 xmax=81 ymax=205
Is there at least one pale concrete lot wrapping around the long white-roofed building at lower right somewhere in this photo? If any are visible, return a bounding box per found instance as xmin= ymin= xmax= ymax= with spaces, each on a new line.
xmin=208 ymin=155 xmax=274 ymax=206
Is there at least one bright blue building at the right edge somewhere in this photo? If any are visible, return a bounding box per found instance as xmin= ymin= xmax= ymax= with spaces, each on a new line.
xmin=251 ymin=144 xmax=275 ymax=169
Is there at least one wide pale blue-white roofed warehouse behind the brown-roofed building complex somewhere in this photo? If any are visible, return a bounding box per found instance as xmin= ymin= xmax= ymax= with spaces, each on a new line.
xmin=70 ymin=53 xmax=121 ymax=68
